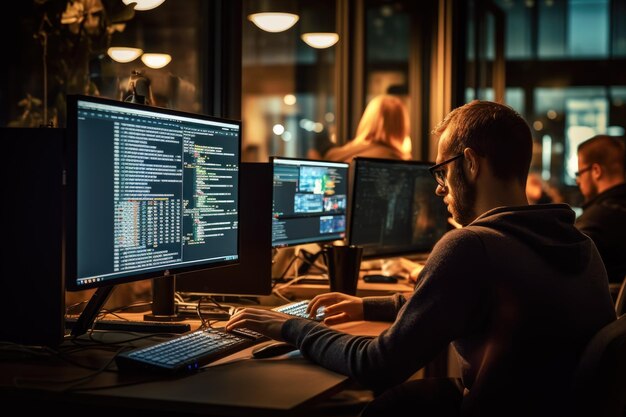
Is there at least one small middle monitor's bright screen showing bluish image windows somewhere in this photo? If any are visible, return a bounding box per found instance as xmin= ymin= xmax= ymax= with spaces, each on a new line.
xmin=272 ymin=158 xmax=350 ymax=247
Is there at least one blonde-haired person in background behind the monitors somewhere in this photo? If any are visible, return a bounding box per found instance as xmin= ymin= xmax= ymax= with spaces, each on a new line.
xmin=324 ymin=95 xmax=411 ymax=162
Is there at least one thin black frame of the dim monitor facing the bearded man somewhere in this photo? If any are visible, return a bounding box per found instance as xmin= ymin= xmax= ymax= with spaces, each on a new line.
xmin=346 ymin=156 xmax=450 ymax=259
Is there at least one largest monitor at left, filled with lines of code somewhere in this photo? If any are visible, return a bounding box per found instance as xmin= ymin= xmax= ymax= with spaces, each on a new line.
xmin=64 ymin=96 xmax=241 ymax=332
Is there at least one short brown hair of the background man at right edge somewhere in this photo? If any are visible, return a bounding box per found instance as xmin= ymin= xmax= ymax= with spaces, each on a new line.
xmin=578 ymin=135 xmax=626 ymax=176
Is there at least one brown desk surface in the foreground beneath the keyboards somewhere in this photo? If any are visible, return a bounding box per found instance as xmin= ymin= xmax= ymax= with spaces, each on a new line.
xmin=0 ymin=316 xmax=386 ymax=416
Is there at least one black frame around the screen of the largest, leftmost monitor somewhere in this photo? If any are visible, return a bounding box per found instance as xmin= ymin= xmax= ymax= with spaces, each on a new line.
xmin=63 ymin=94 xmax=242 ymax=291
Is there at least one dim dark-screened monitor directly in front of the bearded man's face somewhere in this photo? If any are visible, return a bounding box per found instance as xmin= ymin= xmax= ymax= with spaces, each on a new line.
xmin=349 ymin=157 xmax=449 ymax=258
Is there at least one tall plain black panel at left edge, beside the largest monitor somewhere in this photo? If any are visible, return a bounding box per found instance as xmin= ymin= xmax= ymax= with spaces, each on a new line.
xmin=0 ymin=128 xmax=65 ymax=346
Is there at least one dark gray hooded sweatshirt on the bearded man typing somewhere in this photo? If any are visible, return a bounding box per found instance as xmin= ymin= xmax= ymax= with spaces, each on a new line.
xmin=282 ymin=204 xmax=615 ymax=416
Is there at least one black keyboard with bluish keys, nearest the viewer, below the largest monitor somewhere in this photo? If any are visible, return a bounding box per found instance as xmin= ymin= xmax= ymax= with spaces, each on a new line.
xmin=116 ymin=328 xmax=267 ymax=373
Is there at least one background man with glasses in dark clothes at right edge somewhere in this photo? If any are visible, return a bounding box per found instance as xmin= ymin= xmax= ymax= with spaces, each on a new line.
xmin=576 ymin=135 xmax=626 ymax=283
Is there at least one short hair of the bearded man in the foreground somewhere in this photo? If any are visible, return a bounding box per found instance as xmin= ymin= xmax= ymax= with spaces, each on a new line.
xmin=433 ymin=100 xmax=533 ymax=184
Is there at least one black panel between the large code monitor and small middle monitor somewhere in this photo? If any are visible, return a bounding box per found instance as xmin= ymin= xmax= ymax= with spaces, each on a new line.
xmin=176 ymin=163 xmax=272 ymax=295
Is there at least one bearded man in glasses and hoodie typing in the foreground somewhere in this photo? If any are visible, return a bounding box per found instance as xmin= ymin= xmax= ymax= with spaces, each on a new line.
xmin=227 ymin=101 xmax=615 ymax=417
